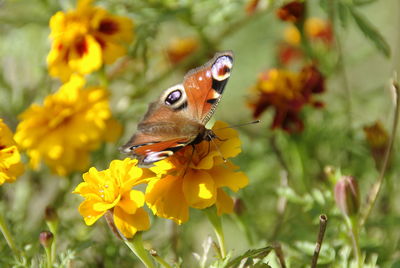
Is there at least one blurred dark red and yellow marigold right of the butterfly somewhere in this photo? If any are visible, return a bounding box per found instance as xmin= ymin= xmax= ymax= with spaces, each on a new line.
xmin=249 ymin=66 xmax=325 ymax=132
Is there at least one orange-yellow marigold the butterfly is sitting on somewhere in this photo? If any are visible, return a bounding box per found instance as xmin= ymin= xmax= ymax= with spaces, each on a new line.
xmin=146 ymin=122 xmax=248 ymax=224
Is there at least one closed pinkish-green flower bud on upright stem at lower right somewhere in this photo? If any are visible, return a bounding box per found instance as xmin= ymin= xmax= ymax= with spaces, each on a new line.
xmin=335 ymin=176 xmax=360 ymax=216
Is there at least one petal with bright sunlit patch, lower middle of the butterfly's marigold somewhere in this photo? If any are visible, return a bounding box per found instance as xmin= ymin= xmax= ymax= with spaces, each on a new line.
xmin=183 ymin=170 xmax=217 ymax=209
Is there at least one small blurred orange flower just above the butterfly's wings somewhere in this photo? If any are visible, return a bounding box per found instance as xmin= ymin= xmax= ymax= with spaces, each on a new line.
xmin=167 ymin=37 xmax=199 ymax=64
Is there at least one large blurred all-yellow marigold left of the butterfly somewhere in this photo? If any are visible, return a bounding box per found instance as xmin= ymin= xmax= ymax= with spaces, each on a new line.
xmin=15 ymin=75 xmax=120 ymax=175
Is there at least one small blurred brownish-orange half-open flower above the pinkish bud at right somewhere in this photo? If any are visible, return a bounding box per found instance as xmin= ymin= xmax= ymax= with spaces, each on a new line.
xmin=364 ymin=121 xmax=390 ymax=168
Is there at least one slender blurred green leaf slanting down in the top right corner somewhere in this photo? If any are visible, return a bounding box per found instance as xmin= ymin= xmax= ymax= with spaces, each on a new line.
xmin=347 ymin=5 xmax=390 ymax=57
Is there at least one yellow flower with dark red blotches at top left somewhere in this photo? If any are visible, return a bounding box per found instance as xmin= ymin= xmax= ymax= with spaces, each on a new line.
xmin=47 ymin=0 xmax=133 ymax=81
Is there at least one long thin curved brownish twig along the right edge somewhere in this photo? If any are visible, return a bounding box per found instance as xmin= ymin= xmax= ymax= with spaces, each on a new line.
xmin=360 ymin=79 xmax=400 ymax=226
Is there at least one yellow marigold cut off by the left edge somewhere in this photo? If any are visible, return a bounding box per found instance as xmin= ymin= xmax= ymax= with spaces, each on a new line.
xmin=0 ymin=118 xmax=24 ymax=185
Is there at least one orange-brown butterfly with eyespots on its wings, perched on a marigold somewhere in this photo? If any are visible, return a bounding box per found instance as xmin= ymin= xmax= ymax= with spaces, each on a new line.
xmin=120 ymin=51 xmax=233 ymax=166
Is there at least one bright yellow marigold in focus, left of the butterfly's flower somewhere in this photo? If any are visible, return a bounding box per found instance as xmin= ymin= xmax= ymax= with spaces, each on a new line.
xmin=73 ymin=158 xmax=154 ymax=238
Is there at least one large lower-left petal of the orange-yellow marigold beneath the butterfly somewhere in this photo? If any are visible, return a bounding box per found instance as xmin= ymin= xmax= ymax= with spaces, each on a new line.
xmin=146 ymin=175 xmax=189 ymax=224
